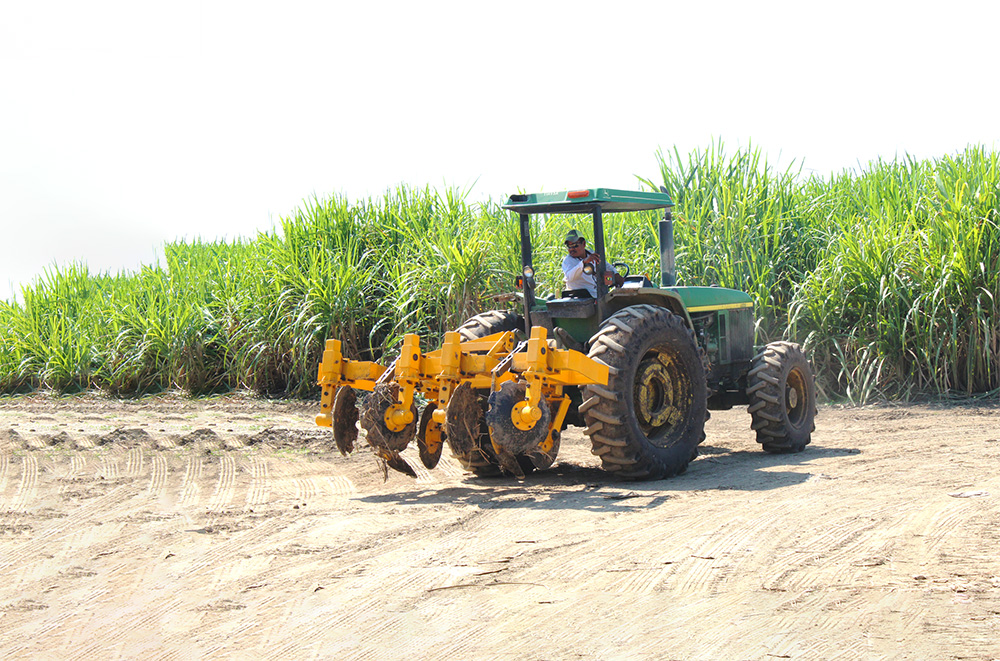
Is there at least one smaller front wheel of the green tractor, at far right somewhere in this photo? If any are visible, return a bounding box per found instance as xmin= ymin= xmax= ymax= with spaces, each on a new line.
xmin=747 ymin=342 xmax=816 ymax=453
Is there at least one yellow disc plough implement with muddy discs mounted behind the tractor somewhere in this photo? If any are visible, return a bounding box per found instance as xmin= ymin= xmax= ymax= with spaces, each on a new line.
xmin=316 ymin=326 xmax=608 ymax=477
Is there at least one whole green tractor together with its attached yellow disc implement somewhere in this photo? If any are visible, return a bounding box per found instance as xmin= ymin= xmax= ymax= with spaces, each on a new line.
xmin=316 ymin=188 xmax=816 ymax=479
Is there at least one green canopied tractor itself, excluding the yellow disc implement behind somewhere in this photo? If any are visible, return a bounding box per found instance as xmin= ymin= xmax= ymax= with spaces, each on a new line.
xmin=503 ymin=188 xmax=816 ymax=479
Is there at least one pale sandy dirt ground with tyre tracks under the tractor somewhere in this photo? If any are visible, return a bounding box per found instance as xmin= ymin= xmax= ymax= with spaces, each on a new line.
xmin=0 ymin=398 xmax=1000 ymax=661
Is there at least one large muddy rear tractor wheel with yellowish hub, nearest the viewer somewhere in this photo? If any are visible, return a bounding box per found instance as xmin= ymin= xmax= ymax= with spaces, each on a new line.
xmin=580 ymin=305 xmax=708 ymax=480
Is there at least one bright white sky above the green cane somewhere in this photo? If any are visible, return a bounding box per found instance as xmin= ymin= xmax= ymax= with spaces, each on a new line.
xmin=0 ymin=0 xmax=1000 ymax=298
